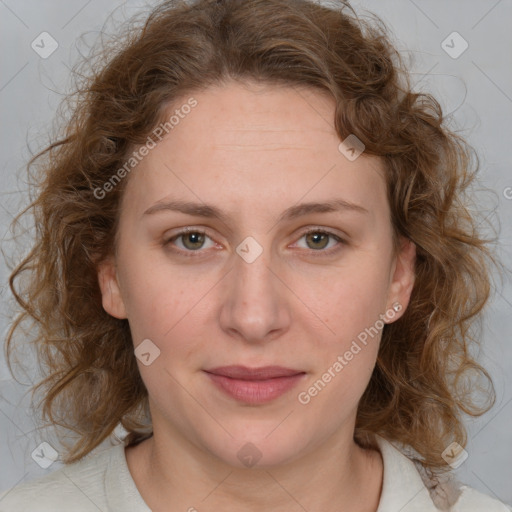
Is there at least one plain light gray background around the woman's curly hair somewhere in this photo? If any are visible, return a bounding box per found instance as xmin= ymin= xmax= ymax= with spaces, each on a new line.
xmin=0 ymin=0 xmax=512 ymax=504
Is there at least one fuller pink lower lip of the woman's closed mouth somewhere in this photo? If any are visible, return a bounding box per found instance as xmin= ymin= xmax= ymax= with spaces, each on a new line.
xmin=206 ymin=372 xmax=305 ymax=404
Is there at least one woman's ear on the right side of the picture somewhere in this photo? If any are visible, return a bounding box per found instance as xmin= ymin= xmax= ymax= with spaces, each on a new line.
xmin=386 ymin=237 xmax=416 ymax=323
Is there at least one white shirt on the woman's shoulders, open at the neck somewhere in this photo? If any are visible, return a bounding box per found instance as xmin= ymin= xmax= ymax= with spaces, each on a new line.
xmin=0 ymin=437 xmax=512 ymax=512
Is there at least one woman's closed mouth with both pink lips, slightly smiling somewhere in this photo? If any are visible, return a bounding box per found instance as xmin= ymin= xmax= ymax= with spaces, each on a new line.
xmin=204 ymin=366 xmax=306 ymax=405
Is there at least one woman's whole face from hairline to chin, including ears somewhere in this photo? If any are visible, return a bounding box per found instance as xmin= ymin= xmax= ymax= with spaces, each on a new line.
xmin=99 ymin=82 xmax=414 ymax=467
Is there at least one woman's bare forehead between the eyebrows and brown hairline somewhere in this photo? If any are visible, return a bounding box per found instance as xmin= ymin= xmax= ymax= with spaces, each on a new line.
xmin=120 ymin=82 xmax=385 ymax=221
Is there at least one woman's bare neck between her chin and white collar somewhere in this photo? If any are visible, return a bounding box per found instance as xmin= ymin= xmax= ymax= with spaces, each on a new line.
xmin=126 ymin=426 xmax=383 ymax=512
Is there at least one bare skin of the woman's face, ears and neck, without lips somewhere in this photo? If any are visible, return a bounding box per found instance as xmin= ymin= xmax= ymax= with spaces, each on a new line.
xmin=99 ymin=82 xmax=415 ymax=512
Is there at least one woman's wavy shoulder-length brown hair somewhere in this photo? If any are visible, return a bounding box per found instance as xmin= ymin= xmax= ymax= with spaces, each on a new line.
xmin=6 ymin=0 xmax=496 ymax=471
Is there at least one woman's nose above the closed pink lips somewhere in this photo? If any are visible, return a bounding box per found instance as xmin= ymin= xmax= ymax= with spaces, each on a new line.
xmin=219 ymin=244 xmax=292 ymax=343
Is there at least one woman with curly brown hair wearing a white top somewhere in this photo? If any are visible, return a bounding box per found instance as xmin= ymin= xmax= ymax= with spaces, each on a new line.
xmin=0 ymin=0 xmax=509 ymax=512
